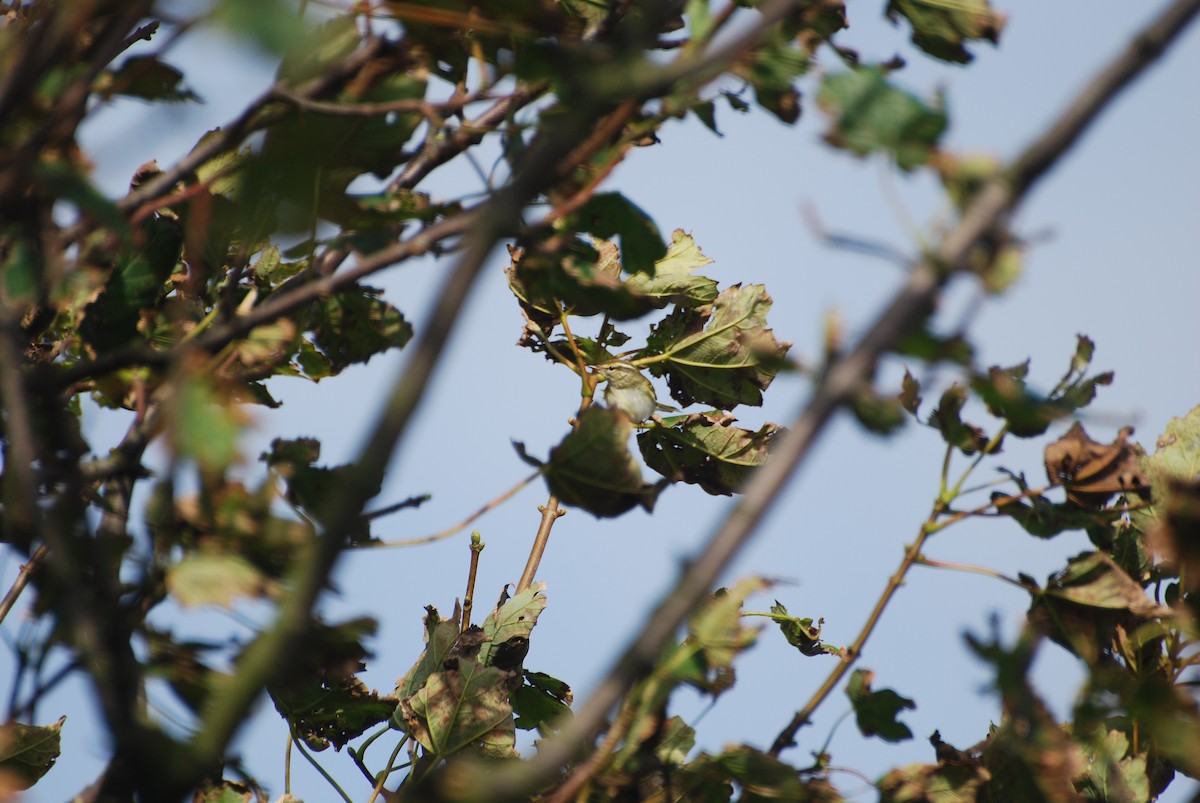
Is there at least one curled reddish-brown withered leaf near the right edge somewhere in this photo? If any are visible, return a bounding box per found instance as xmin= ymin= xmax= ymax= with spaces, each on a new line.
xmin=1045 ymin=421 xmax=1150 ymax=509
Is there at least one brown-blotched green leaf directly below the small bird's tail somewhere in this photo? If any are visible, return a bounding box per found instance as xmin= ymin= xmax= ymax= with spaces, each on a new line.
xmin=637 ymin=411 xmax=782 ymax=496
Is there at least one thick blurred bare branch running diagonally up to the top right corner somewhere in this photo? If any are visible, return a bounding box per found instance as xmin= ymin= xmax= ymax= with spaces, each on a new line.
xmin=488 ymin=0 xmax=1200 ymax=799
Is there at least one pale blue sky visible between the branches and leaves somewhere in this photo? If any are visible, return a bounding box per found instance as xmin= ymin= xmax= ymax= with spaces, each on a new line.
xmin=0 ymin=0 xmax=1200 ymax=801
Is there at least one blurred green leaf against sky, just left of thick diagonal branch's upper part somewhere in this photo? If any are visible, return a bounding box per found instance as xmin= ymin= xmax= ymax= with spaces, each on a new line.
xmin=817 ymin=66 xmax=947 ymax=170
